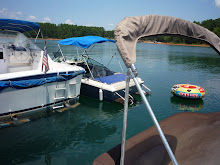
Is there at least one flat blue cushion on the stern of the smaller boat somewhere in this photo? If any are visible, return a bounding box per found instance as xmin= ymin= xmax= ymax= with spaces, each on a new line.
xmin=95 ymin=74 xmax=126 ymax=84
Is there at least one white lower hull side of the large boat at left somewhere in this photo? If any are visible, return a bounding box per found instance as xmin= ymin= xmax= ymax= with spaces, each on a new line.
xmin=0 ymin=74 xmax=82 ymax=115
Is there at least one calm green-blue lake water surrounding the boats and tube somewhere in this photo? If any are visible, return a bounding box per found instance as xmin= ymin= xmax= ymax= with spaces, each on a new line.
xmin=0 ymin=41 xmax=220 ymax=165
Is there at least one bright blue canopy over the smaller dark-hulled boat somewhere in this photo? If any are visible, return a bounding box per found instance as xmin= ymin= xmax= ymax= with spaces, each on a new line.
xmin=58 ymin=36 xmax=115 ymax=49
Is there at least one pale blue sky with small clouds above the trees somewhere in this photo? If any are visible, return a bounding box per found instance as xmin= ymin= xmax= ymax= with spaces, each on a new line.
xmin=0 ymin=0 xmax=220 ymax=30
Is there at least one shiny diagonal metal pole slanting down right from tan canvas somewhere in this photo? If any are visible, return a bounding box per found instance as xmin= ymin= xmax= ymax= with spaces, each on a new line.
xmin=128 ymin=64 xmax=178 ymax=165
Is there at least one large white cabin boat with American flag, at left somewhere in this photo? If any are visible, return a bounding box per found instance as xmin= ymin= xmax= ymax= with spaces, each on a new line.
xmin=0 ymin=19 xmax=85 ymax=116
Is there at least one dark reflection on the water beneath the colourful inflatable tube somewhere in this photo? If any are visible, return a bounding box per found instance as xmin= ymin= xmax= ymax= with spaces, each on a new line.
xmin=170 ymin=96 xmax=204 ymax=112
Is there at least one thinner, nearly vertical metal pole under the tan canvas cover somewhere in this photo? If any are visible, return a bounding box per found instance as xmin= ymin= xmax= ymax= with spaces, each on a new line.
xmin=120 ymin=72 xmax=130 ymax=165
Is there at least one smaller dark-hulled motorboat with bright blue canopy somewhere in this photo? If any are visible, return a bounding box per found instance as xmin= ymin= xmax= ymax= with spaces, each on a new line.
xmin=55 ymin=36 xmax=149 ymax=104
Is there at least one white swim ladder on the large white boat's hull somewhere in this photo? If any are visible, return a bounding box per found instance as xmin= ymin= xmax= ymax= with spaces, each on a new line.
xmin=53 ymin=81 xmax=67 ymax=109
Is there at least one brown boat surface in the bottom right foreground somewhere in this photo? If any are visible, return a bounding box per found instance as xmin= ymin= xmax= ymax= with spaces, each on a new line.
xmin=93 ymin=112 xmax=220 ymax=165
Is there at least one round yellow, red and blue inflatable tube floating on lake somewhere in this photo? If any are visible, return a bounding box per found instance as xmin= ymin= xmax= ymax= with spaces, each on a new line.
xmin=171 ymin=84 xmax=205 ymax=99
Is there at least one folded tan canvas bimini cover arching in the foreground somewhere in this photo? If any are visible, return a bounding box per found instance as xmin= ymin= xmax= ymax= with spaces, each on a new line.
xmin=114 ymin=15 xmax=220 ymax=67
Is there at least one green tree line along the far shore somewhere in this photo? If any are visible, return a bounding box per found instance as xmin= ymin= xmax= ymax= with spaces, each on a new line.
xmin=28 ymin=18 xmax=220 ymax=44
